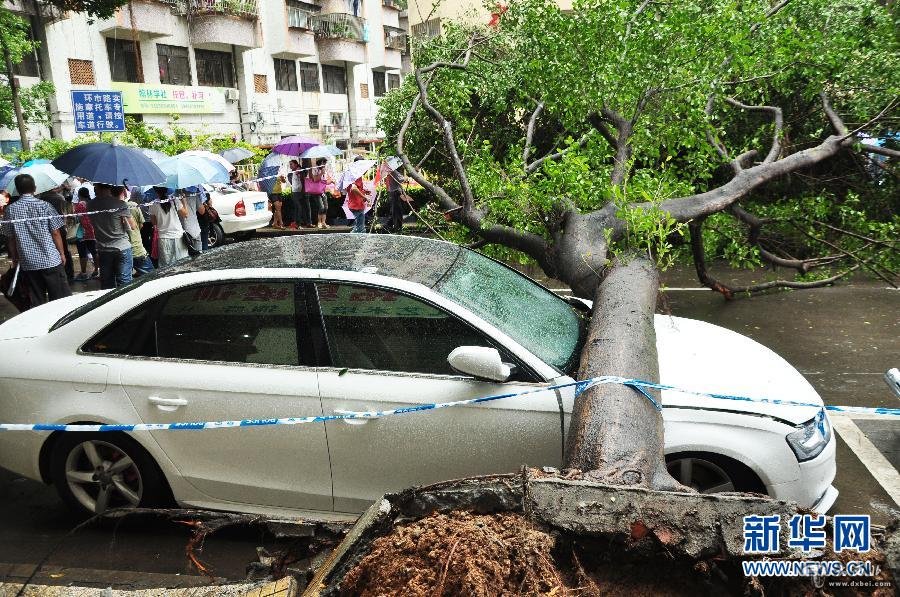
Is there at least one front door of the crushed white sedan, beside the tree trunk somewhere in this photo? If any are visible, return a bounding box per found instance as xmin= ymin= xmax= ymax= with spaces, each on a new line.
xmin=311 ymin=283 xmax=562 ymax=512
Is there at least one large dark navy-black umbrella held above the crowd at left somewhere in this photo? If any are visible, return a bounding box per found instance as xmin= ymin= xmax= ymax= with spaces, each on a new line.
xmin=52 ymin=143 xmax=166 ymax=185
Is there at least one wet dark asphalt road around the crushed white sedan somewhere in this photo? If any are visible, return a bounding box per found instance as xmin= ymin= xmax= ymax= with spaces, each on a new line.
xmin=0 ymin=268 xmax=900 ymax=588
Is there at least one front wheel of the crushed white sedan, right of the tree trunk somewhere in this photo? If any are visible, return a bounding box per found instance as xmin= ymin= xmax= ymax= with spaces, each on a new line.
xmin=666 ymin=453 xmax=766 ymax=494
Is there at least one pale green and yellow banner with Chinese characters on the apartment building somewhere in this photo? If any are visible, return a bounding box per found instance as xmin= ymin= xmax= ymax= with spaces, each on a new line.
xmin=112 ymin=83 xmax=225 ymax=114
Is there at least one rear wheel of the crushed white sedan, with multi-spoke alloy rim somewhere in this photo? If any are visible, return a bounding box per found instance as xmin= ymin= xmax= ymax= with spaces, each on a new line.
xmin=50 ymin=432 xmax=171 ymax=516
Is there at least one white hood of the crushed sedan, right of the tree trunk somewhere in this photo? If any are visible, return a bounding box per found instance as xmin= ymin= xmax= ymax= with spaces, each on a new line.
xmin=656 ymin=315 xmax=822 ymax=425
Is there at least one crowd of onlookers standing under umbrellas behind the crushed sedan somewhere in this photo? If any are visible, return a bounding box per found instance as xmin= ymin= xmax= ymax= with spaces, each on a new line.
xmin=0 ymin=158 xmax=408 ymax=306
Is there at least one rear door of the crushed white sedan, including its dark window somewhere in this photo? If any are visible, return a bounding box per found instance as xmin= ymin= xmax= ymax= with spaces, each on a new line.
xmin=93 ymin=280 xmax=332 ymax=511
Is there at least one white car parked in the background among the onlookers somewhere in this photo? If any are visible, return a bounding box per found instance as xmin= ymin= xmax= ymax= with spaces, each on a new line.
xmin=205 ymin=185 xmax=272 ymax=247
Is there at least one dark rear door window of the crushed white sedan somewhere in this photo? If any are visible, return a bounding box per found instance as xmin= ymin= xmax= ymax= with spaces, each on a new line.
xmin=155 ymin=281 xmax=299 ymax=365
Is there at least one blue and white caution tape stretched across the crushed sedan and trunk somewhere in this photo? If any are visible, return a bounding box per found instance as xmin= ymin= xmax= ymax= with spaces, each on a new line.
xmin=0 ymin=376 xmax=900 ymax=431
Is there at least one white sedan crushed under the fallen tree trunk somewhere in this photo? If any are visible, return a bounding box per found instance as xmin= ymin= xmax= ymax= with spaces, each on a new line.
xmin=0 ymin=234 xmax=837 ymax=520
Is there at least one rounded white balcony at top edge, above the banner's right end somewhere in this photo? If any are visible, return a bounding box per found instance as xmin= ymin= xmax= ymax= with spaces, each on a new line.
xmin=188 ymin=0 xmax=260 ymax=48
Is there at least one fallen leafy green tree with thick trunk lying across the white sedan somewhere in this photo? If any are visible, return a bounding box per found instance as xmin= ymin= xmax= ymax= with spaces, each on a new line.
xmin=336 ymin=0 xmax=900 ymax=590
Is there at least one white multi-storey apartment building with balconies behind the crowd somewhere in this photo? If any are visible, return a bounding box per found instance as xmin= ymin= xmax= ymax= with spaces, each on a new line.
xmin=0 ymin=0 xmax=409 ymax=151
